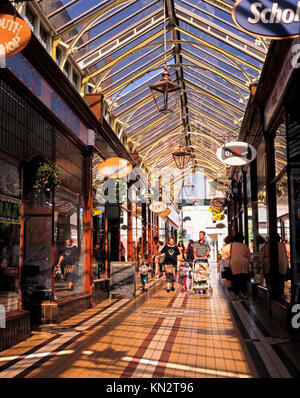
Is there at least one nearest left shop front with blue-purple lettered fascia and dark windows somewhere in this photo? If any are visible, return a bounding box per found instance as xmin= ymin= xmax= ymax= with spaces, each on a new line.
xmin=0 ymin=37 xmax=97 ymax=342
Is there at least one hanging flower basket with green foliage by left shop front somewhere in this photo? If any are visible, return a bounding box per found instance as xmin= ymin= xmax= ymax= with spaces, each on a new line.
xmin=33 ymin=162 xmax=60 ymax=196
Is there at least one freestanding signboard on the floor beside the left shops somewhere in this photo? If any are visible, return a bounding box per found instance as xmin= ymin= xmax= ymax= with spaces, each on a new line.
xmin=109 ymin=261 xmax=136 ymax=298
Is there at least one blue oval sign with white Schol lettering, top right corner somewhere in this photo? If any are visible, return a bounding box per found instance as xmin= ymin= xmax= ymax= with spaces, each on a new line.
xmin=232 ymin=0 xmax=300 ymax=40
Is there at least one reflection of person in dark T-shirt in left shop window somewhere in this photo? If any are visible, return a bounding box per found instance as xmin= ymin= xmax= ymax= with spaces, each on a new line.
xmin=57 ymin=239 xmax=78 ymax=290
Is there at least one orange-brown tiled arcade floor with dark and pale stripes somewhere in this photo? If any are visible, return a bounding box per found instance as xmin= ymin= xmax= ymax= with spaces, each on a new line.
xmin=0 ymin=265 xmax=300 ymax=378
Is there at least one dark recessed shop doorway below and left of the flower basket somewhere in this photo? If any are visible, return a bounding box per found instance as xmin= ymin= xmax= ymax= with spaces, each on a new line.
xmin=23 ymin=156 xmax=53 ymax=324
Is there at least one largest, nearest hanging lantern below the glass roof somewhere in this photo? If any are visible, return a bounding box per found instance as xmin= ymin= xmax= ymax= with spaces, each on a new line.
xmin=150 ymin=65 xmax=181 ymax=113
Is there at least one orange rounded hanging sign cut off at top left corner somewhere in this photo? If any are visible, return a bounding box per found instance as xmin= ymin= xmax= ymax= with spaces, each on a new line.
xmin=0 ymin=14 xmax=31 ymax=57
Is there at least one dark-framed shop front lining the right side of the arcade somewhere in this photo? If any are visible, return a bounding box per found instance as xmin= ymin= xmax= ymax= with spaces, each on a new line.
xmin=229 ymin=39 xmax=300 ymax=327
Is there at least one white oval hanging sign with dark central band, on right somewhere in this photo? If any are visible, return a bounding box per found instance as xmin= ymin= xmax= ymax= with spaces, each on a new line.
xmin=216 ymin=141 xmax=256 ymax=166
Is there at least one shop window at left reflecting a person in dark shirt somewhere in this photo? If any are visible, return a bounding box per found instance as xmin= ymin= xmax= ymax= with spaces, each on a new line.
xmin=54 ymin=189 xmax=86 ymax=299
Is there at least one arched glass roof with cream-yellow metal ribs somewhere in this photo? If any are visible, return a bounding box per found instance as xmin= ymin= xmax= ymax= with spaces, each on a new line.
xmin=38 ymin=0 xmax=269 ymax=178
